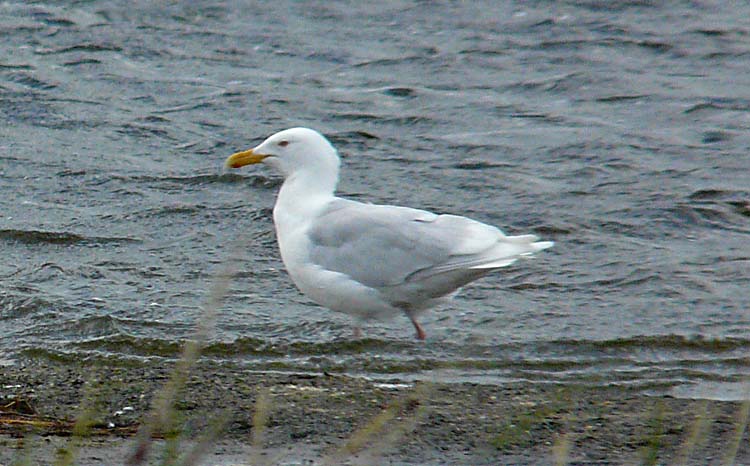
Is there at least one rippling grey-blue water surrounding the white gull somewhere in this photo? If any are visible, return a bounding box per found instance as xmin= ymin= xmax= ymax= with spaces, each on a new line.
xmin=0 ymin=0 xmax=750 ymax=399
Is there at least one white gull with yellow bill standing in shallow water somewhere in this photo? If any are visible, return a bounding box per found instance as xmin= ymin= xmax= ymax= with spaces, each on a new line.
xmin=226 ymin=128 xmax=554 ymax=340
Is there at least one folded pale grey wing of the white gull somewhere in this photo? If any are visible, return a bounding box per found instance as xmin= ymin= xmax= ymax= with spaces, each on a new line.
xmin=308 ymin=199 xmax=540 ymax=288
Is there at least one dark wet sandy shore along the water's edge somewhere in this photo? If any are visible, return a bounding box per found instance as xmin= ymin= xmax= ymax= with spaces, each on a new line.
xmin=0 ymin=358 xmax=750 ymax=465
